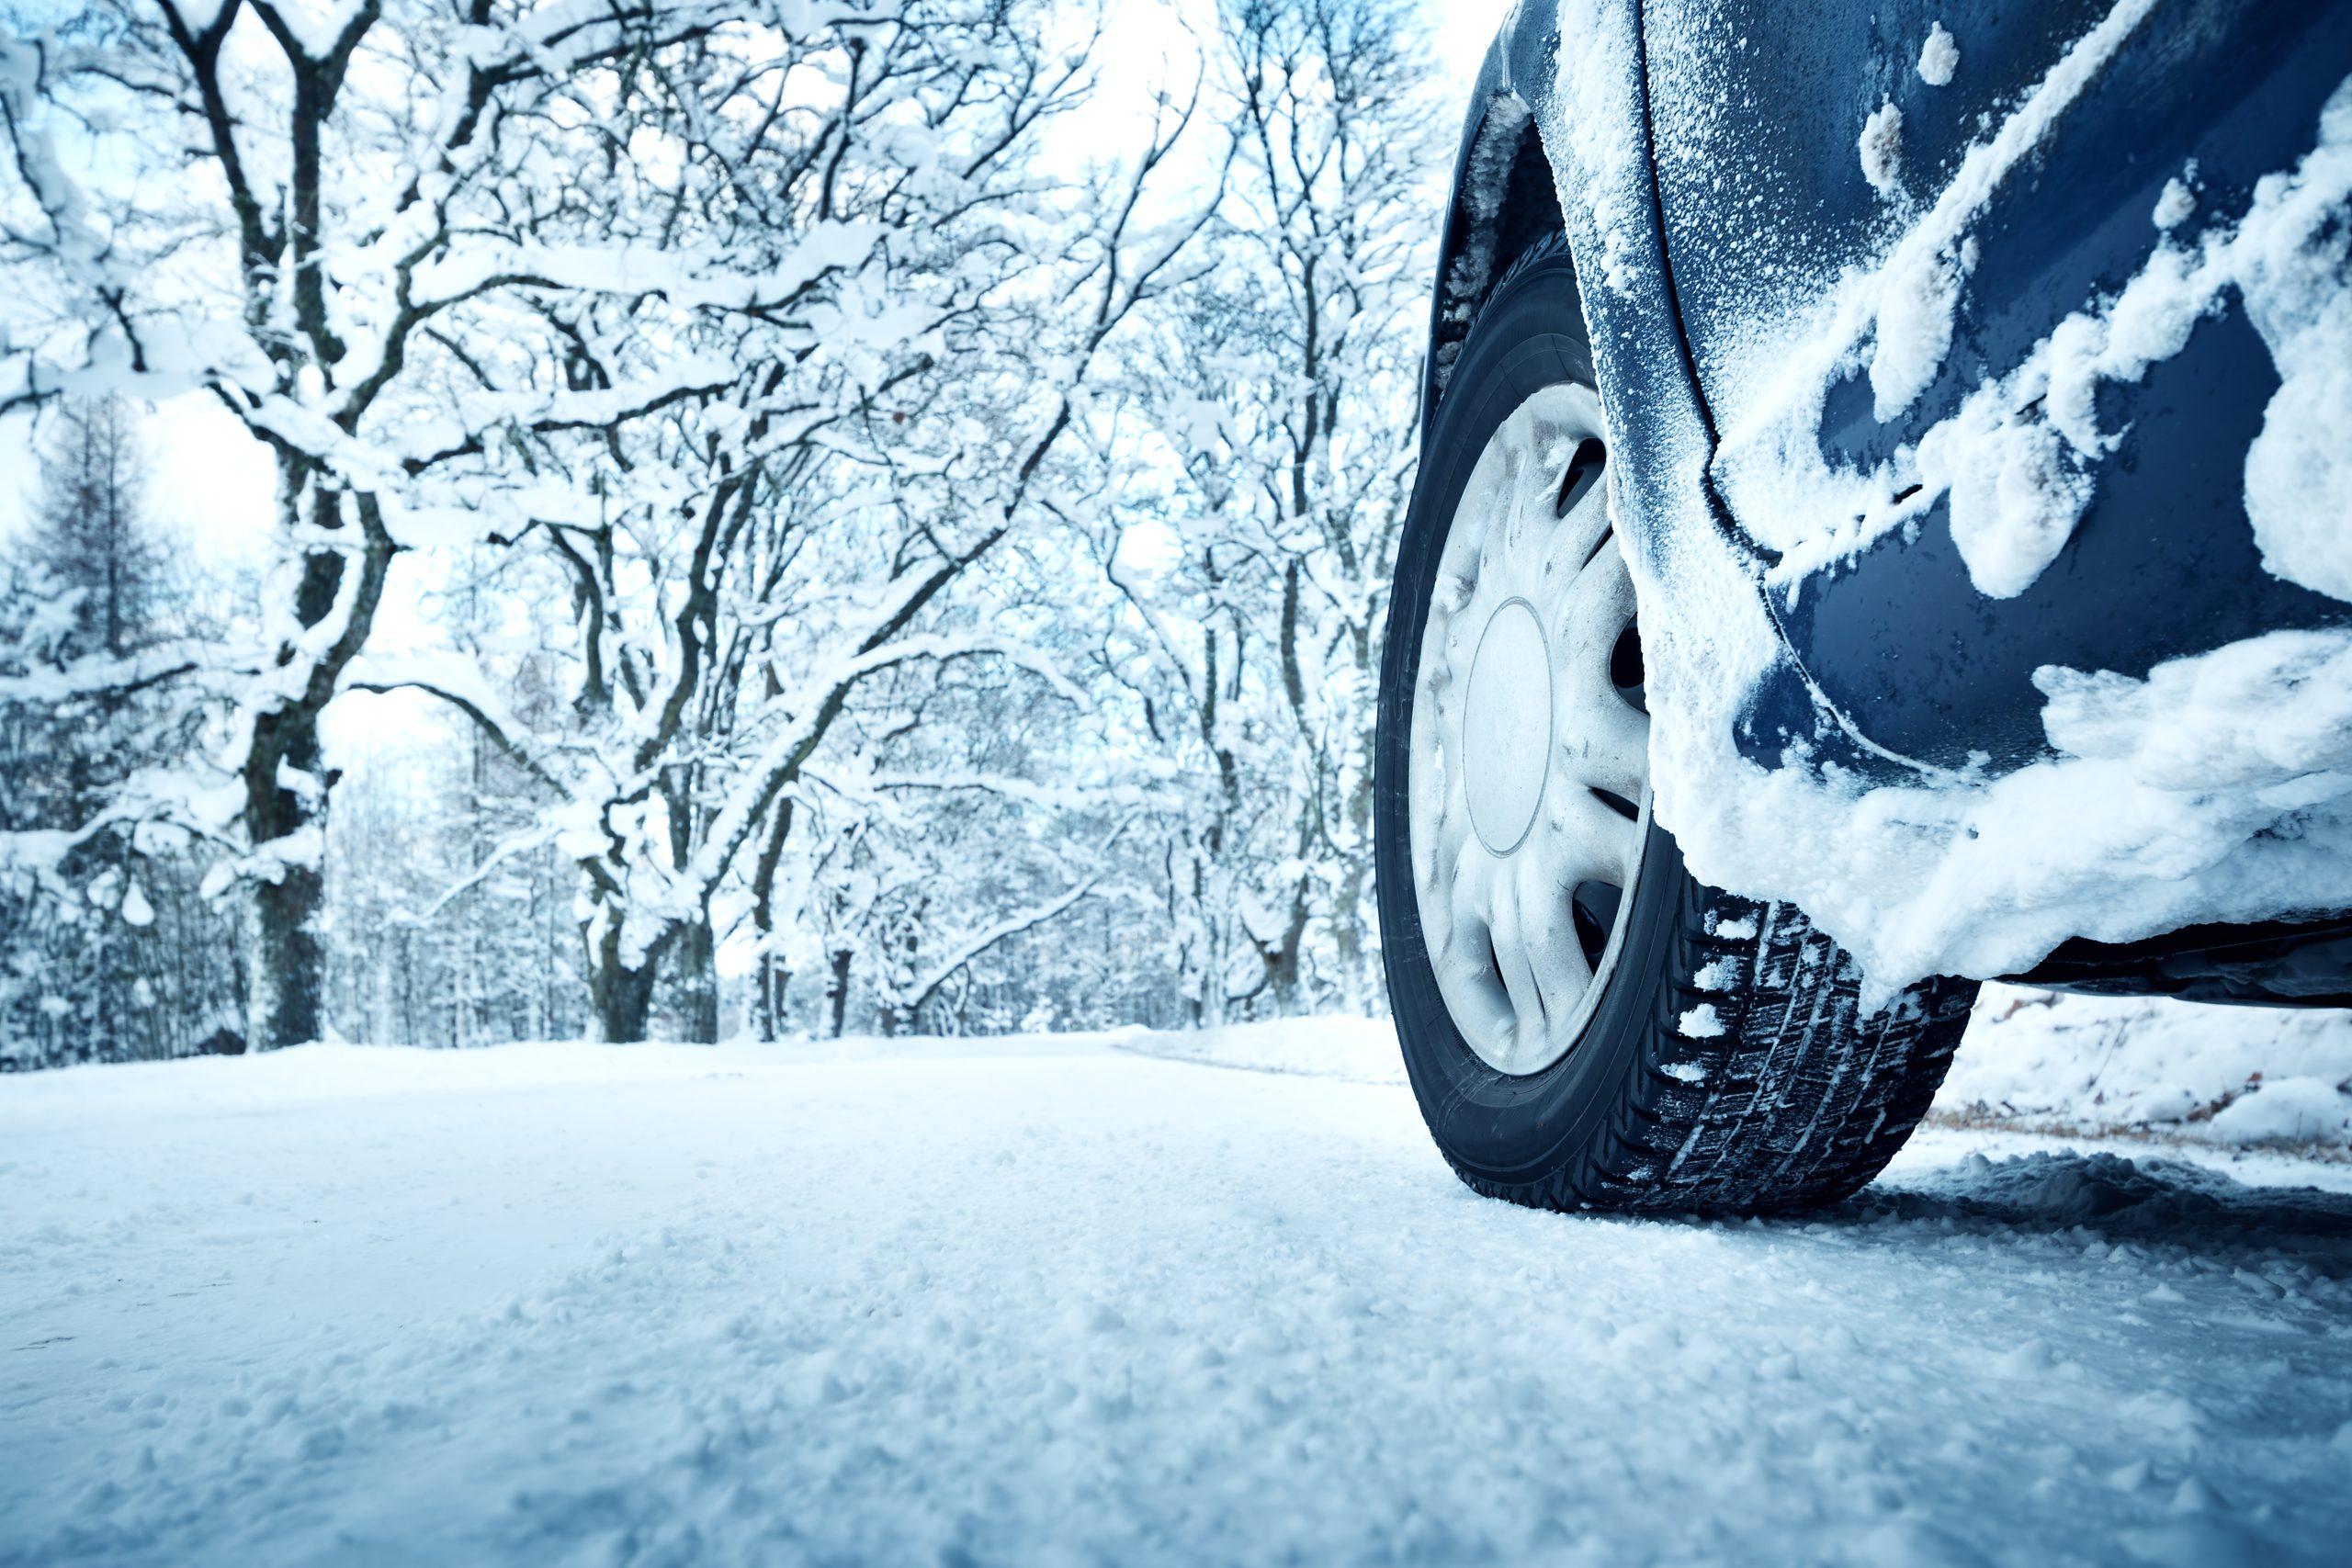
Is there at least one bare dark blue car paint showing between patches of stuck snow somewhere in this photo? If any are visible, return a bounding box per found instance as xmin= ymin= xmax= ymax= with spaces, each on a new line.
xmin=1432 ymin=0 xmax=2352 ymax=778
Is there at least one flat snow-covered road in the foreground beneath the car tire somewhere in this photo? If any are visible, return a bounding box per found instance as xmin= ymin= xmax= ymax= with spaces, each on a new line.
xmin=0 ymin=1042 xmax=2352 ymax=1563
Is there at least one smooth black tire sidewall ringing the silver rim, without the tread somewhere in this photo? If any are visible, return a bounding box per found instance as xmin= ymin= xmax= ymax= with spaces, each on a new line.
xmin=1374 ymin=249 xmax=1689 ymax=1185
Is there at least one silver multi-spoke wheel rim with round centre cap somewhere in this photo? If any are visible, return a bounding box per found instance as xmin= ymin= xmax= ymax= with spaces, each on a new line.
xmin=1411 ymin=386 xmax=1649 ymax=1075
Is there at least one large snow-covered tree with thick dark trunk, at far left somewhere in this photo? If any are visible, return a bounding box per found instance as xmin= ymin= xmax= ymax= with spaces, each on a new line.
xmin=0 ymin=0 xmax=854 ymax=1046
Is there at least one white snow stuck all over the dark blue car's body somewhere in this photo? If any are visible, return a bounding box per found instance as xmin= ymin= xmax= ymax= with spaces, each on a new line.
xmin=1559 ymin=0 xmax=2352 ymax=999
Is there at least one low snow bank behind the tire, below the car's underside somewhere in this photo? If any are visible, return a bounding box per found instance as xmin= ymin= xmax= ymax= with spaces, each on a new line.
xmin=1936 ymin=985 xmax=2352 ymax=1155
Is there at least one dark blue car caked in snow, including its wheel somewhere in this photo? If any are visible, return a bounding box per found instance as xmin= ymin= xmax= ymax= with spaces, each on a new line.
xmin=1374 ymin=0 xmax=2352 ymax=1213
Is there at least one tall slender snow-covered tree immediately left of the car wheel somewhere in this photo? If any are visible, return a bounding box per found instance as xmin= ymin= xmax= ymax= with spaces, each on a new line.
xmin=1099 ymin=0 xmax=1442 ymax=1021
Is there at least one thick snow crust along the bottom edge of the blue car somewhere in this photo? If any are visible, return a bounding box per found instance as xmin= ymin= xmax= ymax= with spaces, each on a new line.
xmin=1651 ymin=630 xmax=2352 ymax=997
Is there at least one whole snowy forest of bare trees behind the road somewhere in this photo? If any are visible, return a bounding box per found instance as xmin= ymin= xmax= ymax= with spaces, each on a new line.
xmin=0 ymin=0 xmax=1453 ymax=1067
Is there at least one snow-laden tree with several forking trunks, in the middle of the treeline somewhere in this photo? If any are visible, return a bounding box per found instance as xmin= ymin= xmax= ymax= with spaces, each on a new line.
xmin=353 ymin=12 xmax=1209 ymax=1039
